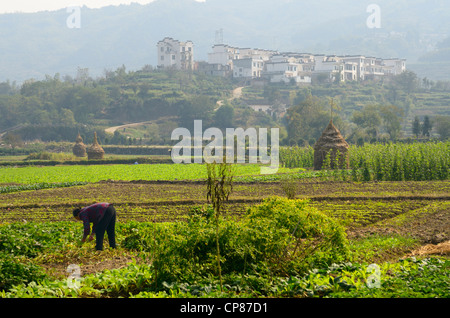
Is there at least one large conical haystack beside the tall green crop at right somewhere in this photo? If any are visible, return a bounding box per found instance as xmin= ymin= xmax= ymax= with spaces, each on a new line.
xmin=314 ymin=120 xmax=349 ymax=170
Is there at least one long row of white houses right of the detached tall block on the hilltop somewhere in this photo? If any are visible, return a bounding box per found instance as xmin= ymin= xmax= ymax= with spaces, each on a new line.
xmin=199 ymin=44 xmax=406 ymax=83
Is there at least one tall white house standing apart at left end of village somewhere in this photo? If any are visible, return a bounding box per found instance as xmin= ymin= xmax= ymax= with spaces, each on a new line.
xmin=157 ymin=37 xmax=194 ymax=70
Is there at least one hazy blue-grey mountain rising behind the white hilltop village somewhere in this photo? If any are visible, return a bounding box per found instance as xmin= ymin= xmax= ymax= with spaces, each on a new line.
xmin=0 ymin=0 xmax=450 ymax=82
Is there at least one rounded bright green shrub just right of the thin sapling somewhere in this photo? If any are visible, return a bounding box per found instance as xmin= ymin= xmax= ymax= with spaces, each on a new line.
xmin=244 ymin=198 xmax=348 ymax=274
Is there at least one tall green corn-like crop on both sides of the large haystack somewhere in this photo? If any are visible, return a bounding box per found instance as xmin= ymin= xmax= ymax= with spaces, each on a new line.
xmin=280 ymin=142 xmax=450 ymax=181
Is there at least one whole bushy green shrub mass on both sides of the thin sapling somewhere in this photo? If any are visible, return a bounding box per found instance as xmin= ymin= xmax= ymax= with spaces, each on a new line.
xmin=123 ymin=198 xmax=348 ymax=284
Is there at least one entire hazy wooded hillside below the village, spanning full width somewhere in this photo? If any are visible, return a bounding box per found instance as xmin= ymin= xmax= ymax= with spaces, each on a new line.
xmin=0 ymin=67 xmax=450 ymax=145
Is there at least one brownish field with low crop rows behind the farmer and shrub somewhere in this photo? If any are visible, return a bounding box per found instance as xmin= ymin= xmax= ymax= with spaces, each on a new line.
xmin=0 ymin=180 xmax=450 ymax=238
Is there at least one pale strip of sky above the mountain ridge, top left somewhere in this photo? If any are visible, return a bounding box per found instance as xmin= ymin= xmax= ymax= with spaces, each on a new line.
xmin=0 ymin=0 xmax=205 ymax=13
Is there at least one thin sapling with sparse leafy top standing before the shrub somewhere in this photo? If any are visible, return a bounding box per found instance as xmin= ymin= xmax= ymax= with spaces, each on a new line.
xmin=206 ymin=160 xmax=233 ymax=291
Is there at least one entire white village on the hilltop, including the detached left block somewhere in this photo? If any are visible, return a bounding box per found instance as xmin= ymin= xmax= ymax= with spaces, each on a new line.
xmin=157 ymin=37 xmax=406 ymax=85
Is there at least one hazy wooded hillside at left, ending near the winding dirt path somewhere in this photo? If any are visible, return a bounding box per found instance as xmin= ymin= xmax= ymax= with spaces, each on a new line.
xmin=0 ymin=68 xmax=237 ymax=141
